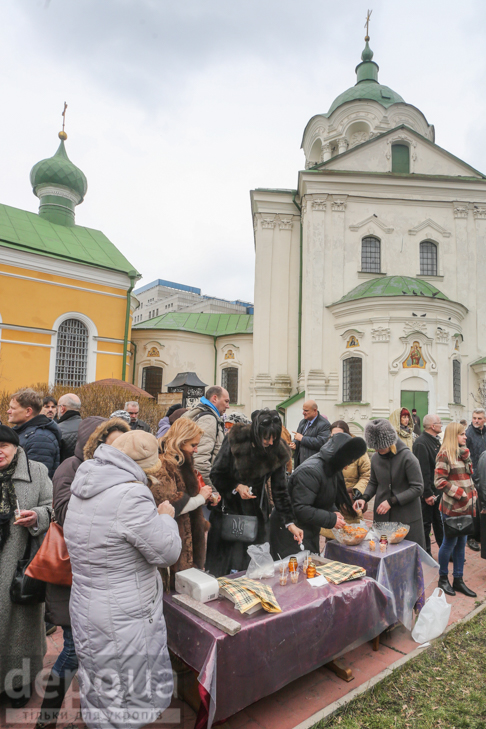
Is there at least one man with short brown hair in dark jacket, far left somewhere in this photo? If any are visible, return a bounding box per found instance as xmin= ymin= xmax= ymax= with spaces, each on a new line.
xmin=7 ymin=387 xmax=61 ymax=478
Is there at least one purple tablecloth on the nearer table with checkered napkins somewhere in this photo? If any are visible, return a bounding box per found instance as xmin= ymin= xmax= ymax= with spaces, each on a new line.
xmin=164 ymin=574 xmax=397 ymax=727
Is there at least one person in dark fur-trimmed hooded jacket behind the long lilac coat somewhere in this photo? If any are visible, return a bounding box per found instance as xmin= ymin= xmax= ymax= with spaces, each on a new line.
xmin=35 ymin=415 xmax=130 ymax=729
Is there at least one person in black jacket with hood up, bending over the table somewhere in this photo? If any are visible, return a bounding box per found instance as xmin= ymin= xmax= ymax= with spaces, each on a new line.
xmin=271 ymin=433 xmax=366 ymax=559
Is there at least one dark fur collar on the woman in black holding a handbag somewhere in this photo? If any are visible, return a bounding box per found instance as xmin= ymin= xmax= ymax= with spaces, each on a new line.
xmin=227 ymin=423 xmax=290 ymax=483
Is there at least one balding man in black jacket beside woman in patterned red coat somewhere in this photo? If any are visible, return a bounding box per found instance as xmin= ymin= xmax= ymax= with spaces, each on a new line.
xmin=413 ymin=415 xmax=444 ymax=554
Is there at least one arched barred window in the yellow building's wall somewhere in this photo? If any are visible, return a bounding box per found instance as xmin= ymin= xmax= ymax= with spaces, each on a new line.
xmin=55 ymin=319 xmax=89 ymax=387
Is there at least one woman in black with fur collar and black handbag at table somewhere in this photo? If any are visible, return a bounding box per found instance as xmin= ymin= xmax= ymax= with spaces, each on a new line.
xmin=206 ymin=408 xmax=303 ymax=577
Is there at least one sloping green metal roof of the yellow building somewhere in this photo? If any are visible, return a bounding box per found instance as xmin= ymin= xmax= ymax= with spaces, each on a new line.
xmin=0 ymin=205 xmax=137 ymax=275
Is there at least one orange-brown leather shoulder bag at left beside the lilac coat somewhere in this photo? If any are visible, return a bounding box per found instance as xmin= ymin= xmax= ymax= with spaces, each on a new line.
xmin=25 ymin=521 xmax=73 ymax=587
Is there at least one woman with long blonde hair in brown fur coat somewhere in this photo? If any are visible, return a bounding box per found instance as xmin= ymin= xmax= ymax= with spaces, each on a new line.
xmin=150 ymin=418 xmax=212 ymax=589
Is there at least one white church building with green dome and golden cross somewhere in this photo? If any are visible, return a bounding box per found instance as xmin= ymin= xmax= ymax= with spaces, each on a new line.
xmin=248 ymin=38 xmax=486 ymax=433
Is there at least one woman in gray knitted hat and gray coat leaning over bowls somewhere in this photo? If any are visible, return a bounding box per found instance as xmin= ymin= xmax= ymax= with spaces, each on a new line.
xmin=354 ymin=419 xmax=425 ymax=549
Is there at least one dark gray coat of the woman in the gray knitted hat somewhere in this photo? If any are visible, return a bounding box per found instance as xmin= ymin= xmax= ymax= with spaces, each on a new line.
xmin=363 ymin=438 xmax=425 ymax=549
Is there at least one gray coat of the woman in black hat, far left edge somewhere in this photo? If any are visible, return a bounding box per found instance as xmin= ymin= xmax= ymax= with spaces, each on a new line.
xmin=0 ymin=447 xmax=52 ymax=692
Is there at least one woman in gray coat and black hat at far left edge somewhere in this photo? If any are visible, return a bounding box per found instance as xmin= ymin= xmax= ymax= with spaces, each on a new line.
xmin=0 ymin=425 xmax=52 ymax=708
